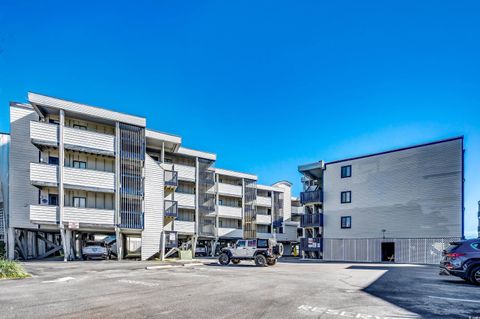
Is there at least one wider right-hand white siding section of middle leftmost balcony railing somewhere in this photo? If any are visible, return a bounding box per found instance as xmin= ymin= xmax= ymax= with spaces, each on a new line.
xmin=64 ymin=167 xmax=115 ymax=193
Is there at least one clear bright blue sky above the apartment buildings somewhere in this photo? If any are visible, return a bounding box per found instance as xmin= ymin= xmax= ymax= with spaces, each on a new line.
xmin=0 ymin=0 xmax=480 ymax=235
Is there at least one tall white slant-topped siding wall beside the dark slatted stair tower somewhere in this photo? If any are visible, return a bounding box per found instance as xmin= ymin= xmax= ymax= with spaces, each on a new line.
xmin=142 ymin=154 xmax=164 ymax=260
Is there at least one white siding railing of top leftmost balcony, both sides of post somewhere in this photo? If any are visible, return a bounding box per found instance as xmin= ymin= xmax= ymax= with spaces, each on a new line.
xmin=30 ymin=121 xmax=115 ymax=156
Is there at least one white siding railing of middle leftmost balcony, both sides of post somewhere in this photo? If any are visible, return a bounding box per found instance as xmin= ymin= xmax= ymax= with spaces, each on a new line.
xmin=30 ymin=163 xmax=115 ymax=193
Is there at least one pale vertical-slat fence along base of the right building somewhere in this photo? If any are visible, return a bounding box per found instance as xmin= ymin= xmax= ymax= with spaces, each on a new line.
xmin=323 ymin=237 xmax=460 ymax=264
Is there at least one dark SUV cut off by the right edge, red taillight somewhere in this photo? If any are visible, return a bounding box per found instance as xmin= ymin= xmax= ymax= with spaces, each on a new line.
xmin=440 ymin=238 xmax=480 ymax=285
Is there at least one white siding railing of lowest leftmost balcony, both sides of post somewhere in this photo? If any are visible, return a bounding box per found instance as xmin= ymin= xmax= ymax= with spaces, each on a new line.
xmin=30 ymin=205 xmax=114 ymax=227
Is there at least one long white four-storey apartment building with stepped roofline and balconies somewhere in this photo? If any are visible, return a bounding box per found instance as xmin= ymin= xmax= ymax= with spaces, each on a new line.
xmin=2 ymin=93 xmax=301 ymax=260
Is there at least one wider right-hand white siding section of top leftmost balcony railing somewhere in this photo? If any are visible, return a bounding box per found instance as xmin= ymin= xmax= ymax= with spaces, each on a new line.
xmin=64 ymin=127 xmax=115 ymax=154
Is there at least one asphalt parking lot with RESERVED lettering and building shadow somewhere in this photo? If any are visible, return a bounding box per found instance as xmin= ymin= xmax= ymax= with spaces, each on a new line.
xmin=0 ymin=260 xmax=480 ymax=319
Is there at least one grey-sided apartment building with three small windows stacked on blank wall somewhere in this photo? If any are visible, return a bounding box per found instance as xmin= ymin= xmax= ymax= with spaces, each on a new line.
xmin=299 ymin=137 xmax=464 ymax=264
